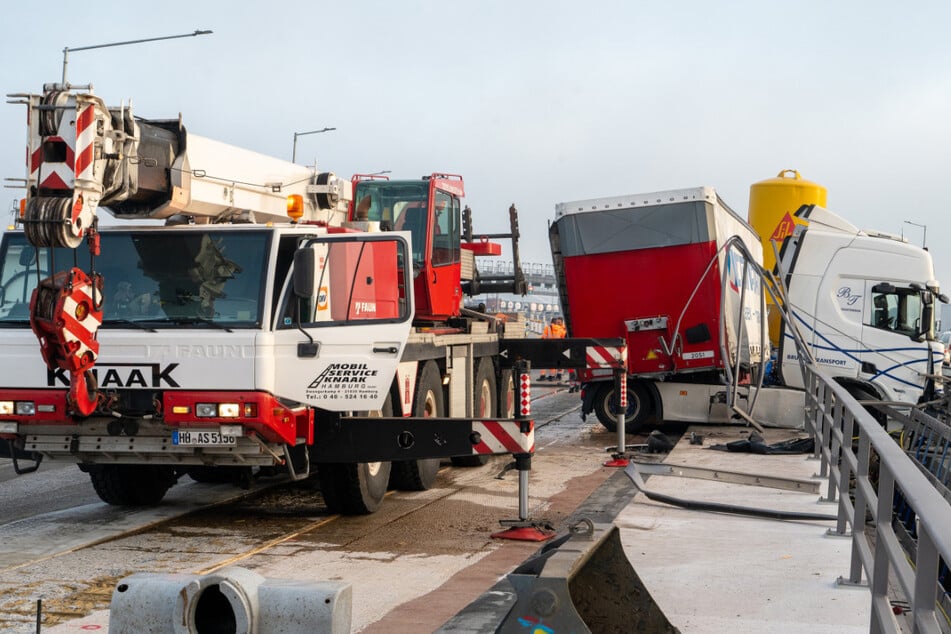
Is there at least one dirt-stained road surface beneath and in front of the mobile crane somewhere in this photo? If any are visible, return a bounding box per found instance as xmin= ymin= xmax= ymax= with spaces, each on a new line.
xmin=0 ymin=388 xmax=636 ymax=634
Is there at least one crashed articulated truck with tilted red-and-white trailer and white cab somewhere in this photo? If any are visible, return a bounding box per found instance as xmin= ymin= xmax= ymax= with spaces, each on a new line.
xmin=550 ymin=187 xmax=947 ymax=431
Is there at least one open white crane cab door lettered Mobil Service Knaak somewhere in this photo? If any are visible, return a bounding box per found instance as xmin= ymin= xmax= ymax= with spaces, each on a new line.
xmin=274 ymin=233 xmax=413 ymax=411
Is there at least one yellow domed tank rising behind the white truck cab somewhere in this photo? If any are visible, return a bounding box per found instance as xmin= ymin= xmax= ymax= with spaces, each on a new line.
xmin=747 ymin=169 xmax=826 ymax=347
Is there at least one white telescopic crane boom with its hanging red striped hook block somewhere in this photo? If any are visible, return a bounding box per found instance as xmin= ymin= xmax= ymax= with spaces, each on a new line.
xmin=9 ymin=84 xmax=351 ymax=415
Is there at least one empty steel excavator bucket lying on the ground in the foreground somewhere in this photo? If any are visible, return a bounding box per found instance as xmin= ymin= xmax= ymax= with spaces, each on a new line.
xmin=497 ymin=519 xmax=679 ymax=634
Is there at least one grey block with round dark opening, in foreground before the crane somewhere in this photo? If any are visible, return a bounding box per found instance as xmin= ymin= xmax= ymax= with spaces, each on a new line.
xmin=109 ymin=566 xmax=352 ymax=634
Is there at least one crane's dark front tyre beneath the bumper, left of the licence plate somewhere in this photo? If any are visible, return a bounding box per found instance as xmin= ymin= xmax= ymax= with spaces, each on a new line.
xmin=89 ymin=464 xmax=176 ymax=506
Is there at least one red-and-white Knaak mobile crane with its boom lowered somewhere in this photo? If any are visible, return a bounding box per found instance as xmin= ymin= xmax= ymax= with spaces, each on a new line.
xmin=0 ymin=84 xmax=534 ymax=513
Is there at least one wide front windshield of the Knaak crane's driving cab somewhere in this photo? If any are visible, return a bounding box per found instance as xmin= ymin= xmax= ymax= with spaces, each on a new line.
xmin=0 ymin=228 xmax=270 ymax=328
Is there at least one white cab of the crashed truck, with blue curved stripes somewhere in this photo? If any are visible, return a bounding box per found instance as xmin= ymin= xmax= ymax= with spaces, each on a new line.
xmin=778 ymin=205 xmax=947 ymax=404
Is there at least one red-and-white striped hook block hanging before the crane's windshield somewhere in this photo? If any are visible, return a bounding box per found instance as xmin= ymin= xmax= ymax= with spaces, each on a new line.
xmin=30 ymin=267 xmax=102 ymax=416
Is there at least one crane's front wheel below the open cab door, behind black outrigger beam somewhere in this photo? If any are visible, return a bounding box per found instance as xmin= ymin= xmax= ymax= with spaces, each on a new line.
xmin=317 ymin=395 xmax=393 ymax=515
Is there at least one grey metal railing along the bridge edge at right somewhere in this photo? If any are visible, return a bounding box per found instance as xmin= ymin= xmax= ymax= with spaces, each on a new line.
xmin=803 ymin=365 xmax=951 ymax=634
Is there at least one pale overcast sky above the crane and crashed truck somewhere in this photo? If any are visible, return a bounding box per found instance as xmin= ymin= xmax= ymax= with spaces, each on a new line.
xmin=0 ymin=0 xmax=951 ymax=290
